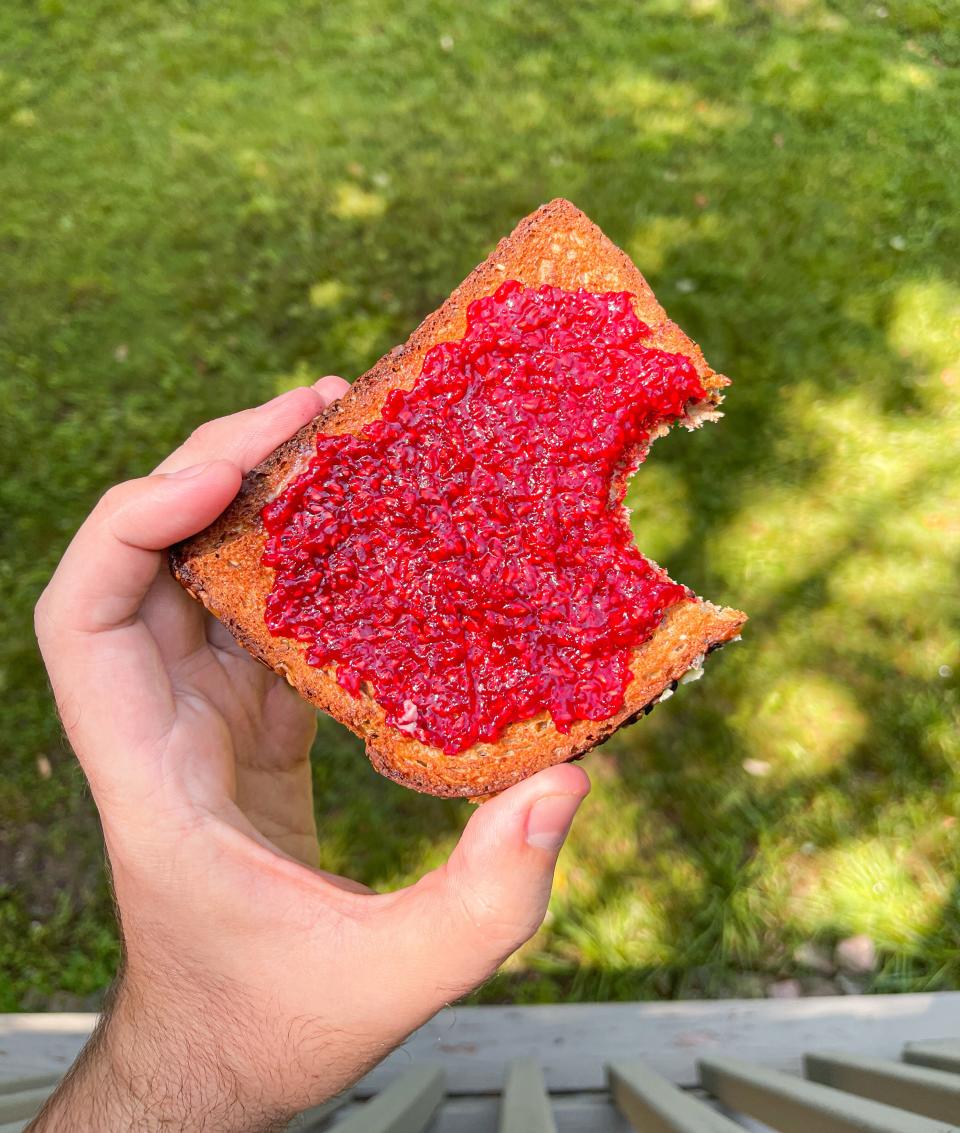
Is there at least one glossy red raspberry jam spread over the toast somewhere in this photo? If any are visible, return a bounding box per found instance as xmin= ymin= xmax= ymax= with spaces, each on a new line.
xmin=263 ymin=281 xmax=706 ymax=755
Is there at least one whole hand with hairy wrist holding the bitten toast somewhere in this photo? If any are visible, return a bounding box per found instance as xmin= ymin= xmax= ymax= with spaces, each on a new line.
xmin=33 ymin=377 xmax=589 ymax=1133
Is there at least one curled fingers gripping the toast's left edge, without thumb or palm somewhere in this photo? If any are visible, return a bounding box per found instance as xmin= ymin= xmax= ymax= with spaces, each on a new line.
xmin=36 ymin=377 xmax=355 ymax=820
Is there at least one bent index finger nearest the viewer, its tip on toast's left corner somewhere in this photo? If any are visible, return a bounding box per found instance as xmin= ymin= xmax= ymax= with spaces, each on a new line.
xmin=36 ymin=461 xmax=240 ymax=797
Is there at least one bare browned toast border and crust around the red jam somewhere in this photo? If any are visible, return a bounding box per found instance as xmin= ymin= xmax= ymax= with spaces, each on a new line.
xmin=170 ymin=199 xmax=746 ymax=799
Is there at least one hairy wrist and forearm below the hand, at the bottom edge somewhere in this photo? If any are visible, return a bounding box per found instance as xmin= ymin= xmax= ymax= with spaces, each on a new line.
xmin=28 ymin=983 xmax=292 ymax=1133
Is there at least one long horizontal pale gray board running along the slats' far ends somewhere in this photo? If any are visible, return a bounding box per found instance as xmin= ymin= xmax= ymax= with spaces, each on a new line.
xmin=0 ymin=991 xmax=960 ymax=1097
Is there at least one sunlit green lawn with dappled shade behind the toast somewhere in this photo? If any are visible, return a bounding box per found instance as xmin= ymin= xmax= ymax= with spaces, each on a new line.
xmin=0 ymin=0 xmax=960 ymax=1010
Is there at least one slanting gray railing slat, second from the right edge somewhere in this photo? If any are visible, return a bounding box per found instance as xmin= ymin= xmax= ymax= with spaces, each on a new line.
xmin=804 ymin=1053 xmax=960 ymax=1122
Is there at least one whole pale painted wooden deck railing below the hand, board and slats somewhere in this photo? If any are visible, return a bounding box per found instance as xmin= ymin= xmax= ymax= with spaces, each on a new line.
xmin=0 ymin=993 xmax=960 ymax=1133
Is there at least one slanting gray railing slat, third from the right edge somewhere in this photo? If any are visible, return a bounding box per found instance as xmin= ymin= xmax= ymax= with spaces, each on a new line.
xmin=699 ymin=1058 xmax=958 ymax=1133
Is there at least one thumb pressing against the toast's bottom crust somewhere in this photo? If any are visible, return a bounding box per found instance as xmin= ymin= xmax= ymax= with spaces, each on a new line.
xmin=398 ymin=764 xmax=591 ymax=998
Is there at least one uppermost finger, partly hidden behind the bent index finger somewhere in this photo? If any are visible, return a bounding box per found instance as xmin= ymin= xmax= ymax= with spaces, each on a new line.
xmin=156 ymin=374 xmax=349 ymax=472
